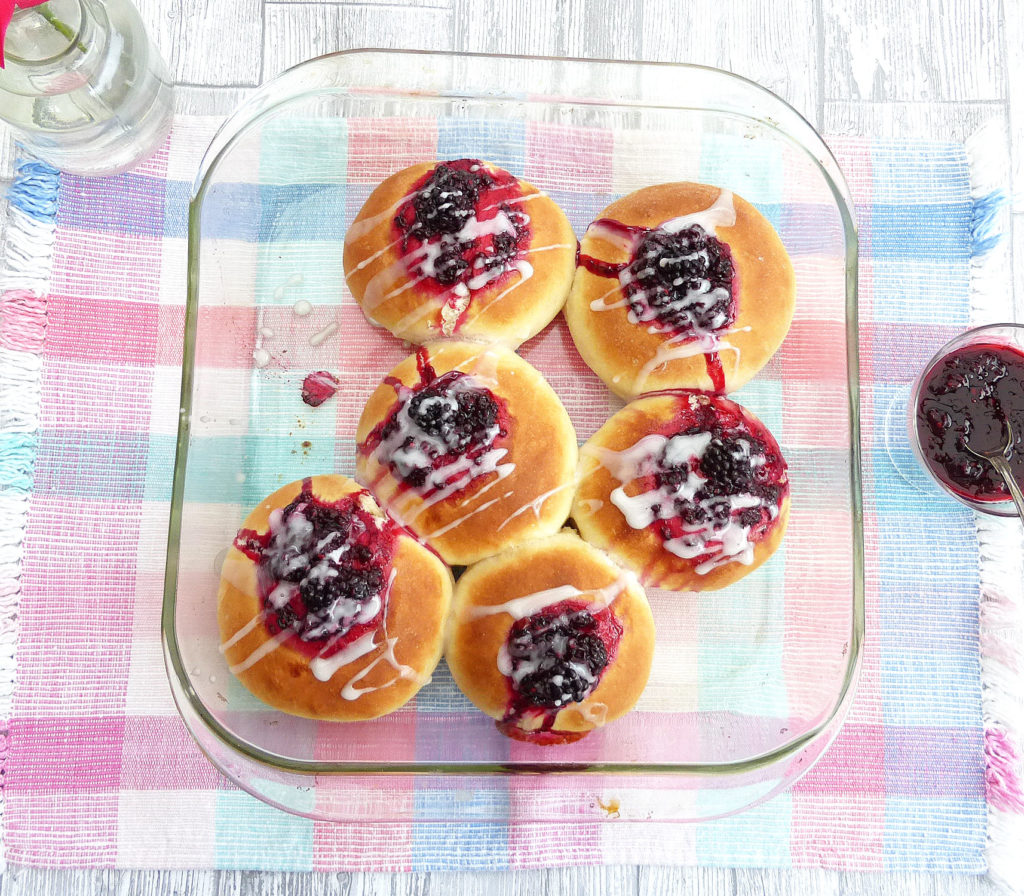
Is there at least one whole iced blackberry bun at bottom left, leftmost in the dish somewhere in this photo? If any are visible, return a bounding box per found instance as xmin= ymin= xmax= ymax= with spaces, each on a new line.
xmin=217 ymin=476 xmax=454 ymax=721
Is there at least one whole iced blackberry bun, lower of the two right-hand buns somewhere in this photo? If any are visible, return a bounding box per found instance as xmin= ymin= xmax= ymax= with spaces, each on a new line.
xmin=572 ymin=392 xmax=790 ymax=591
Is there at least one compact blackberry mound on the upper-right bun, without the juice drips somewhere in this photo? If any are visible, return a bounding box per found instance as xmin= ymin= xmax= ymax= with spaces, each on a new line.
xmin=618 ymin=224 xmax=736 ymax=337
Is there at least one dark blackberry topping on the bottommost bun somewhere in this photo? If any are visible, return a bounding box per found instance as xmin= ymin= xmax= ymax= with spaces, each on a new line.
xmin=500 ymin=601 xmax=623 ymax=730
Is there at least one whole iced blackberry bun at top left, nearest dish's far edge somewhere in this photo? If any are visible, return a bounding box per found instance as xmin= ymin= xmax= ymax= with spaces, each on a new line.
xmin=344 ymin=159 xmax=577 ymax=348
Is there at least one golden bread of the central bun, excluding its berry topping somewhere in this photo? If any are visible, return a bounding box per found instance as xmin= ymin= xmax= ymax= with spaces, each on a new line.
xmin=355 ymin=342 xmax=578 ymax=566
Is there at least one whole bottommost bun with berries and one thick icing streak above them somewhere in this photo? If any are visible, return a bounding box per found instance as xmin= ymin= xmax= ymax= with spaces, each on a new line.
xmin=445 ymin=529 xmax=654 ymax=744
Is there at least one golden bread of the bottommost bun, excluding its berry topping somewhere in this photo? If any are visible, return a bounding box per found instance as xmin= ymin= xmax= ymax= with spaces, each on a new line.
xmin=445 ymin=529 xmax=654 ymax=739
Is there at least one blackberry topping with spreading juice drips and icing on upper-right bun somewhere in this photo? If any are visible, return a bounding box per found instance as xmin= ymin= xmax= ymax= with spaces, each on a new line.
xmin=579 ymin=193 xmax=738 ymax=392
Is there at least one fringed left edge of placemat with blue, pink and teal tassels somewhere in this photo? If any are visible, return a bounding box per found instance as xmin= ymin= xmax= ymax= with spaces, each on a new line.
xmin=0 ymin=161 xmax=60 ymax=870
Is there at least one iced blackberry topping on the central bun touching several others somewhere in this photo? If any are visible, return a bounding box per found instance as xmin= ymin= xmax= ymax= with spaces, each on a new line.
xmin=359 ymin=356 xmax=508 ymax=497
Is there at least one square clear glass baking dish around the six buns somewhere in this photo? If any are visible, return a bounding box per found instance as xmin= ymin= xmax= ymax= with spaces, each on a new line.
xmin=163 ymin=50 xmax=863 ymax=822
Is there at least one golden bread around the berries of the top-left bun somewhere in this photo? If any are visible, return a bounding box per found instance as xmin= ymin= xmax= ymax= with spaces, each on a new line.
xmin=344 ymin=162 xmax=577 ymax=348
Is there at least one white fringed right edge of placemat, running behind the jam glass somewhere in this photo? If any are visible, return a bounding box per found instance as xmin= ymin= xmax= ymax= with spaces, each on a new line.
xmin=967 ymin=121 xmax=1024 ymax=892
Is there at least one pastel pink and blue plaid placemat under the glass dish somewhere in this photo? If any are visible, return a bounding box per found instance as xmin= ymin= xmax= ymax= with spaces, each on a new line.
xmin=0 ymin=113 xmax=1024 ymax=873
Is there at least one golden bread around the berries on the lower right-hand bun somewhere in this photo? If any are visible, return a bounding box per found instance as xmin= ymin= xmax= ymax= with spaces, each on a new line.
xmin=572 ymin=392 xmax=790 ymax=591
